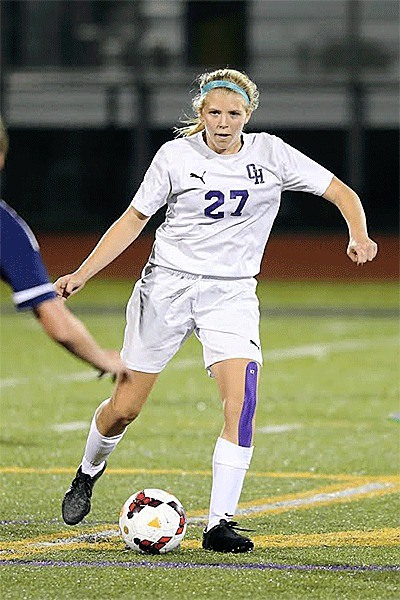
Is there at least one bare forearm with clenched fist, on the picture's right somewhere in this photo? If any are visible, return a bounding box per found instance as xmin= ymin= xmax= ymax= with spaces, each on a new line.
xmin=323 ymin=177 xmax=378 ymax=265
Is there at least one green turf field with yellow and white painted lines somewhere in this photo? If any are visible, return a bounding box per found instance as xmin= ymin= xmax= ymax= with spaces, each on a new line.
xmin=0 ymin=280 xmax=400 ymax=600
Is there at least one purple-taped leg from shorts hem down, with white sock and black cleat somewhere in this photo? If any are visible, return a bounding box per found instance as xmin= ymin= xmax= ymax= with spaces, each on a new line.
xmin=203 ymin=359 xmax=258 ymax=552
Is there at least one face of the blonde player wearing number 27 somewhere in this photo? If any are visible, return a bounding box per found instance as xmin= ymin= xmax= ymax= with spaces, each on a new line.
xmin=200 ymin=89 xmax=251 ymax=154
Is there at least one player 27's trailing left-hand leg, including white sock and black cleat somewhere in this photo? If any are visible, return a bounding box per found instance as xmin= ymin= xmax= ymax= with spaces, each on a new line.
xmin=62 ymin=371 xmax=158 ymax=525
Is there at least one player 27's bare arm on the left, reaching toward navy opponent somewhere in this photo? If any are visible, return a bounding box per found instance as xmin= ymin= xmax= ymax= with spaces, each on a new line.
xmin=55 ymin=206 xmax=149 ymax=298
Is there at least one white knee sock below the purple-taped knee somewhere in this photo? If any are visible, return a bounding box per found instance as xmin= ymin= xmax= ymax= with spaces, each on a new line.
xmin=207 ymin=438 xmax=254 ymax=531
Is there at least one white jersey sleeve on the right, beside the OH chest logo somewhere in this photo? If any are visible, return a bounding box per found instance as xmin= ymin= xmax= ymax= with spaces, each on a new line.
xmin=278 ymin=140 xmax=333 ymax=196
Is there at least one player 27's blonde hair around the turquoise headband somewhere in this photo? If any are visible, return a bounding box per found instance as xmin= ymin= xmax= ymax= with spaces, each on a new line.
xmin=174 ymin=69 xmax=260 ymax=137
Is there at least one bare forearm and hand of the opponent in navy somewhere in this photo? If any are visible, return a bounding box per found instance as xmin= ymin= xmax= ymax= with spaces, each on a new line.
xmin=34 ymin=298 xmax=128 ymax=375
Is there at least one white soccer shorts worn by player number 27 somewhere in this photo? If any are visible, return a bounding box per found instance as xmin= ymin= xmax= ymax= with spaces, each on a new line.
xmin=121 ymin=265 xmax=262 ymax=373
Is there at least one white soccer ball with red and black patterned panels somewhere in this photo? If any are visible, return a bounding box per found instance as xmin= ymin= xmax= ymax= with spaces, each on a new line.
xmin=119 ymin=489 xmax=187 ymax=554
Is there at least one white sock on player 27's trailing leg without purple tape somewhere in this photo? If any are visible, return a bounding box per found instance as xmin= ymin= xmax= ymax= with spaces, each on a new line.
xmin=81 ymin=398 xmax=126 ymax=477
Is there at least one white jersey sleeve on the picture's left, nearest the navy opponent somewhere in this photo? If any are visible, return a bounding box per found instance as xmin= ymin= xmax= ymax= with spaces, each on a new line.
xmin=131 ymin=144 xmax=171 ymax=217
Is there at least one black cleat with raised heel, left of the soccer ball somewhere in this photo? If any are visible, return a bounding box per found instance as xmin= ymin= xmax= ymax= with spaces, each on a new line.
xmin=62 ymin=463 xmax=107 ymax=525
